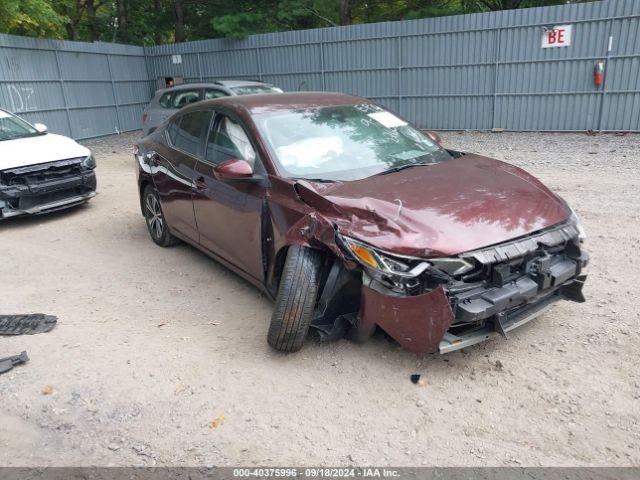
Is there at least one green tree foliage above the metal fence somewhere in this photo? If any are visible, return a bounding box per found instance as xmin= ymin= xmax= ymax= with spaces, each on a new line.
xmin=0 ymin=0 xmax=591 ymax=45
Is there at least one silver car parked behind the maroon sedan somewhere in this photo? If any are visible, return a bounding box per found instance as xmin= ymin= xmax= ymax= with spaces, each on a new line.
xmin=142 ymin=80 xmax=282 ymax=136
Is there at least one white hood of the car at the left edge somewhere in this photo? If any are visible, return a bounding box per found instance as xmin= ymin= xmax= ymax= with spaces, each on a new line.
xmin=0 ymin=133 xmax=91 ymax=170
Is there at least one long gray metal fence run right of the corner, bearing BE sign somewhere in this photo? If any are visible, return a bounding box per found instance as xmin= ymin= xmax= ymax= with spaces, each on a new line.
xmin=146 ymin=0 xmax=640 ymax=131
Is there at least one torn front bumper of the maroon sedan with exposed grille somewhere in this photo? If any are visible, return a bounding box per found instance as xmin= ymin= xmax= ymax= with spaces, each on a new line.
xmin=357 ymin=223 xmax=588 ymax=355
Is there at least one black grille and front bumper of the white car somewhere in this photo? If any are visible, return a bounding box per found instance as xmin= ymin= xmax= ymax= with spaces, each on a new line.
xmin=0 ymin=159 xmax=96 ymax=219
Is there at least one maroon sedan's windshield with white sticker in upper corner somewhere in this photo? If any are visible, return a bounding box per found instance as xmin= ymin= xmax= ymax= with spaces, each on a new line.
xmin=254 ymin=104 xmax=451 ymax=181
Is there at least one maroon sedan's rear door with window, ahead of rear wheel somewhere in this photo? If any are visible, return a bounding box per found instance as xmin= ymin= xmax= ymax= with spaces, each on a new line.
xmin=152 ymin=110 xmax=212 ymax=242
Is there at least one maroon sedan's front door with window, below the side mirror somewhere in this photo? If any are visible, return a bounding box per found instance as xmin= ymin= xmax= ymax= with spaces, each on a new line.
xmin=193 ymin=114 xmax=266 ymax=280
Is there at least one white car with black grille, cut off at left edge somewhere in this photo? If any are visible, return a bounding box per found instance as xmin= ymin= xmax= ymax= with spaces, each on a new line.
xmin=0 ymin=109 xmax=96 ymax=220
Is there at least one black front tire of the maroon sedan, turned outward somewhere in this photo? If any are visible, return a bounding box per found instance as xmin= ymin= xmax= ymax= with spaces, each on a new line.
xmin=267 ymin=245 xmax=322 ymax=352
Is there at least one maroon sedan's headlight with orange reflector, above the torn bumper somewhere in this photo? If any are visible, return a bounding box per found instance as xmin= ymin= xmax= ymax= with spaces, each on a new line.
xmin=339 ymin=236 xmax=429 ymax=278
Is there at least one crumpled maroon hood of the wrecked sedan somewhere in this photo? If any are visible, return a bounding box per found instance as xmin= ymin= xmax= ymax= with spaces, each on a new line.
xmin=298 ymin=154 xmax=571 ymax=257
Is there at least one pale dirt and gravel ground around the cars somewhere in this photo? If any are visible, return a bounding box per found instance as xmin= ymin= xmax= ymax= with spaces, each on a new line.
xmin=0 ymin=133 xmax=640 ymax=466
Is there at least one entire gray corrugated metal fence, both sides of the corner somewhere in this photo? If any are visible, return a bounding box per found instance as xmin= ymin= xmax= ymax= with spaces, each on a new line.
xmin=0 ymin=0 xmax=640 ymax=138
